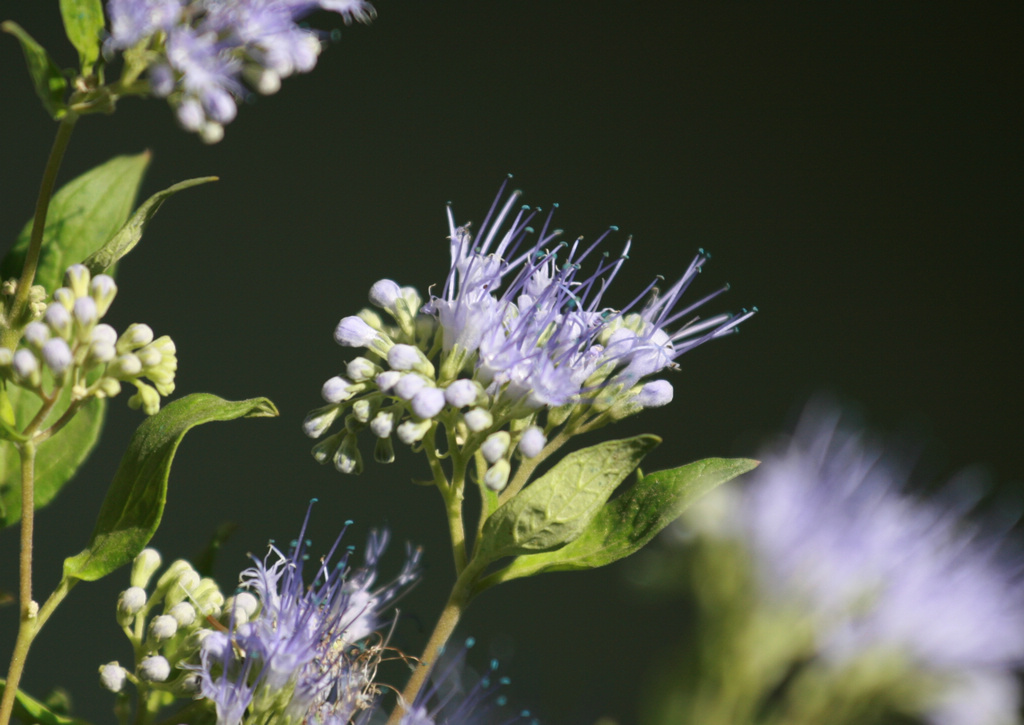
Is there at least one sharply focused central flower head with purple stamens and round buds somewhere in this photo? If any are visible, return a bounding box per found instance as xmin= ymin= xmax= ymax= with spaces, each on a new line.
xmin=304 ymin=191 xmax=756 ymax=492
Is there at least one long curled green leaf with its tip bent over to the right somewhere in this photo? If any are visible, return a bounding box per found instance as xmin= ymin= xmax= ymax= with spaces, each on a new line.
xmin=63 ymin=393 xmax=278 ymax=582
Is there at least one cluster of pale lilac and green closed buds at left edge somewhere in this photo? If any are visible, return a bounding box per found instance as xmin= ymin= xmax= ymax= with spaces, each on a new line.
xmin=0 ymin=264 xmax=178 ymax=415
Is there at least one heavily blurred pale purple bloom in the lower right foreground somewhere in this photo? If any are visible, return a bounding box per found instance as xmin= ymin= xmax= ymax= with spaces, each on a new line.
xmin=732 ymin=407 xmax=1024 ymax=725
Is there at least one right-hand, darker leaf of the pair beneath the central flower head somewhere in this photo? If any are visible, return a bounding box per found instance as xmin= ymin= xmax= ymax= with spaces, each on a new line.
xmin=488 ymin=458 xmax=759 ymax=586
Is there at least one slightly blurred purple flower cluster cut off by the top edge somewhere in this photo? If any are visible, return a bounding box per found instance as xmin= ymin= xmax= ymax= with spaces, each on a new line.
xmin=105 ymin=0 xmax=375 ymax=142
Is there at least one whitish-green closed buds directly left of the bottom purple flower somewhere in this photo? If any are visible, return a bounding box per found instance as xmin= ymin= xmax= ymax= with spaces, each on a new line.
xmin=99 ymin=549 xmax=226 ymax=697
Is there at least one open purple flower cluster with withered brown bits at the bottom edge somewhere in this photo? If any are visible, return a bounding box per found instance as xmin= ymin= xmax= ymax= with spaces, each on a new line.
xmin=193 ymin=503 xmax=420 ymax=725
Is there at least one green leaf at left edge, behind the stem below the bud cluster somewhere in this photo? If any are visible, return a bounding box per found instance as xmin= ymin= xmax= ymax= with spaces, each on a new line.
xmin=0 ymin=393 xmax=106 ymax=527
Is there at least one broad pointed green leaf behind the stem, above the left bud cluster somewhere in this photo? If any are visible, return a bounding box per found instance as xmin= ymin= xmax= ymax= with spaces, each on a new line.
xmin=0 ymin=152 xmax=151 ymax=292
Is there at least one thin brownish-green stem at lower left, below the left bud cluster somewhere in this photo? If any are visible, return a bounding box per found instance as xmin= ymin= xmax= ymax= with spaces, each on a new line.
xmin=0 ymin=440 xmax=39 ymax=725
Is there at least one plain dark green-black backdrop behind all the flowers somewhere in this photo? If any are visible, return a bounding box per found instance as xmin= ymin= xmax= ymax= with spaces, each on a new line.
xmin=0 ymin=0 xmax=1024 ymax=723
